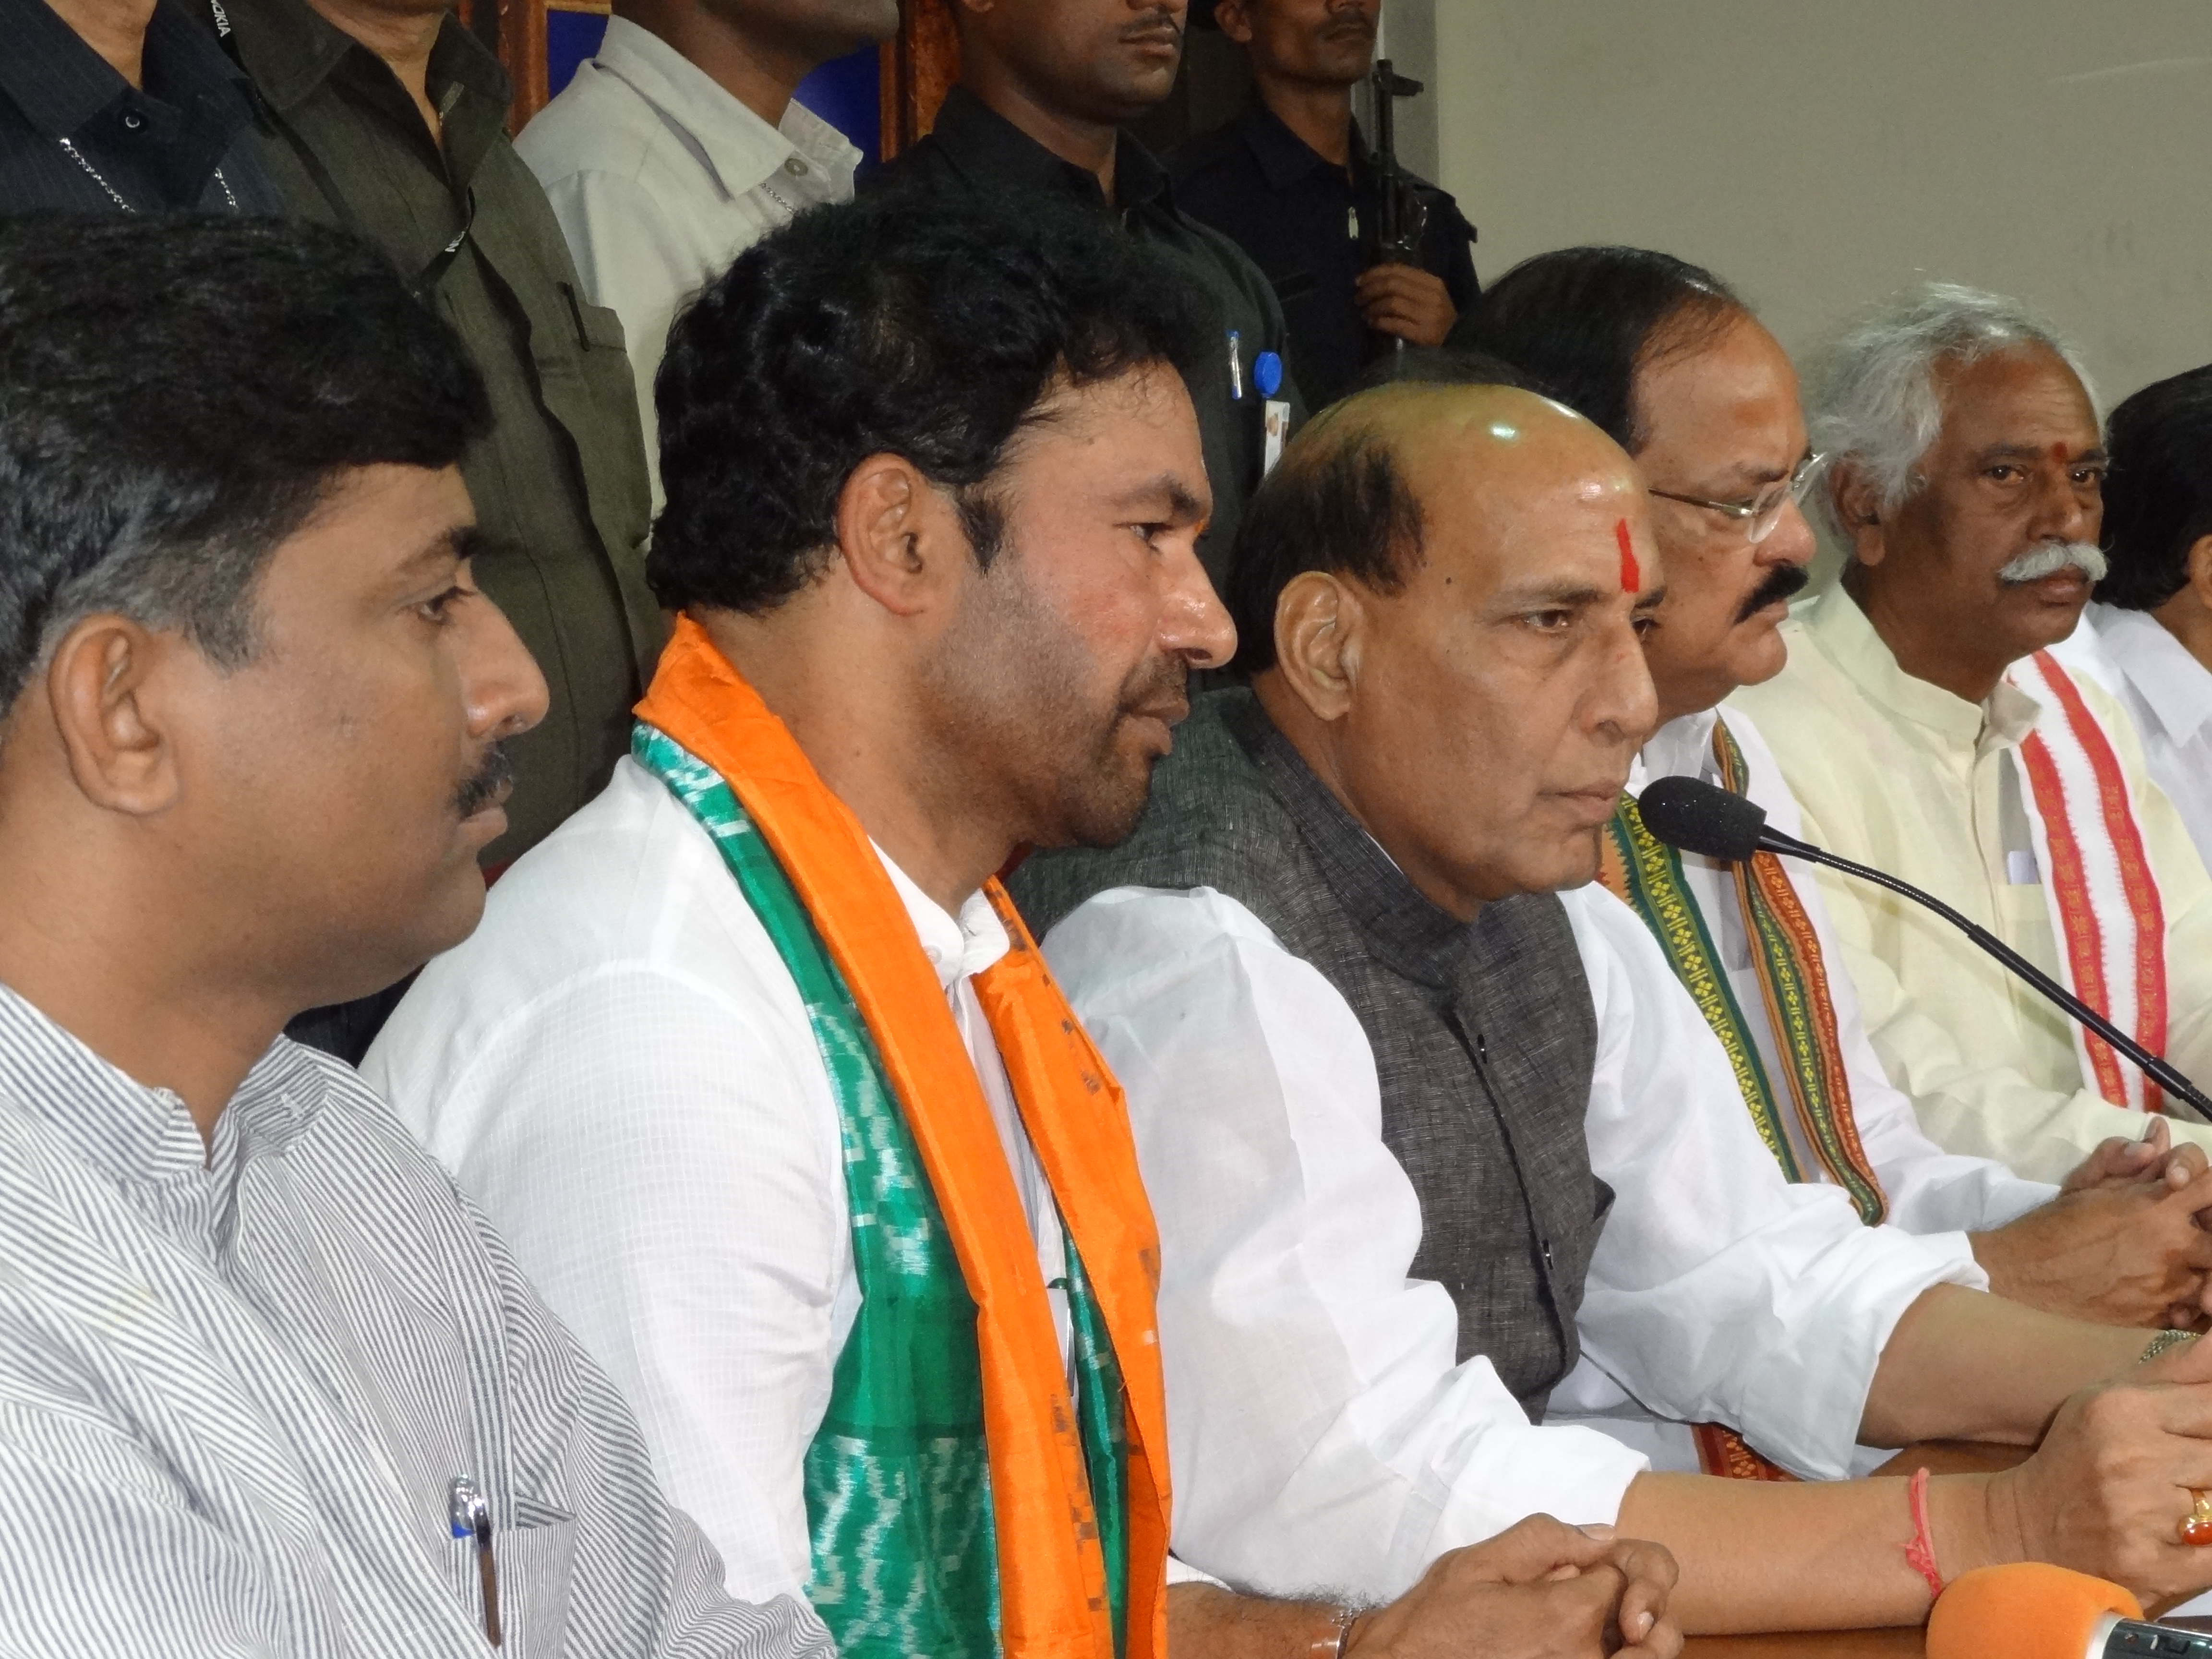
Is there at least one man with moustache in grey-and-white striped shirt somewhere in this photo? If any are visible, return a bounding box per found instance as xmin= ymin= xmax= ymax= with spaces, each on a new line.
xmin=0 ymin=219 xmax=830 ymax=1659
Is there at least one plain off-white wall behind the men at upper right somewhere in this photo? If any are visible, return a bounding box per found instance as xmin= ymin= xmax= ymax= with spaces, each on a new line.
xmin=1436 ymin=0 xmax=2212 ymax=400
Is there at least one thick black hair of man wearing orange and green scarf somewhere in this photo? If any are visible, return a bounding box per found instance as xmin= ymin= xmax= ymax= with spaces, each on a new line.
xmin=646 ymin=190 xmax=1210 ymax=613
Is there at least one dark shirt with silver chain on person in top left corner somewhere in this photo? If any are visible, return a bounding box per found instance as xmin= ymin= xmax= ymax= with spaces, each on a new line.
xmin=0 ymin=0 xmax=283 ymax=212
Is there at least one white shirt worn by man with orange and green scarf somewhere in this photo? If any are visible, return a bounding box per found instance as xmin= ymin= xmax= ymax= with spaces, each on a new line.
xmin=363 ymin=759 xmax=1069 ymax=1599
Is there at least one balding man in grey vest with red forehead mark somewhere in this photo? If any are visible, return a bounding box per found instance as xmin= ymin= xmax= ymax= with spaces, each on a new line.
xmin=1013 ymin=383 xmax=2201 ymax=1633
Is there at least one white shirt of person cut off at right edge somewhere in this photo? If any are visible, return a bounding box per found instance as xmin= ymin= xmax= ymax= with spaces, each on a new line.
xmin=2053 ymin=604 xmax=2212 ymax=865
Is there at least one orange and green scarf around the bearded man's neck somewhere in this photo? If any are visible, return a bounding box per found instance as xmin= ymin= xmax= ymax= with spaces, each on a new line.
xmin=633 ymin=617 xmax=1168 ymax=1659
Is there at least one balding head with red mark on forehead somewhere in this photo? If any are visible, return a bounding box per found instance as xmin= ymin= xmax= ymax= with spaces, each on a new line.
xmin=1232 ymin=385 xmax=1661 ymax=918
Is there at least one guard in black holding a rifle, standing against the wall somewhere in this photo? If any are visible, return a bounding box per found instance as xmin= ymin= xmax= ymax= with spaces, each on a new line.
xmin=1168 ymin=0 xmax=1480 ymax=407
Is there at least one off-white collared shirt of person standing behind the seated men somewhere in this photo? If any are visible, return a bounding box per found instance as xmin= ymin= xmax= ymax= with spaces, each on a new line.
xmin=516 ymin=18 xmax=861 ymax=506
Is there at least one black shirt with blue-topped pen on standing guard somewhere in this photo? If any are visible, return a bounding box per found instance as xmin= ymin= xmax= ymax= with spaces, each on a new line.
xmin=867 ymin=86 xmax=1305 ymax=589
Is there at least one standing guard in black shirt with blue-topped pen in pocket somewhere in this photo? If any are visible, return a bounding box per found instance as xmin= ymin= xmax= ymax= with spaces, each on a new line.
xmin=863 ymin=0 xmax=1305 ymax=589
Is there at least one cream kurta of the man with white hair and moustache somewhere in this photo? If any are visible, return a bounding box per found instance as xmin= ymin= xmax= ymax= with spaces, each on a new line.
xmin=1728 ymin=589 xmax=2212 ymax=1181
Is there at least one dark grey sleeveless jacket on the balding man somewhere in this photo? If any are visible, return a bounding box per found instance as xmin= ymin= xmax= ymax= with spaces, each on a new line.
xmin=1013 ymin=688 xmax=1612 ymax=1418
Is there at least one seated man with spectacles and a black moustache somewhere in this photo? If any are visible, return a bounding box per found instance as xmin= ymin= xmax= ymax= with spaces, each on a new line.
xmin=1471 ymin=248 xmax=2212 ymax=1473
